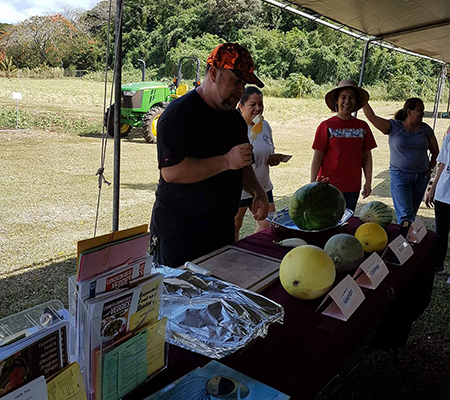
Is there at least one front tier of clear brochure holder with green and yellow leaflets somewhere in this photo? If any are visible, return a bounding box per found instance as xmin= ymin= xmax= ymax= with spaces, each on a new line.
xmin=69 ymin=274 xmax=170 ymax=400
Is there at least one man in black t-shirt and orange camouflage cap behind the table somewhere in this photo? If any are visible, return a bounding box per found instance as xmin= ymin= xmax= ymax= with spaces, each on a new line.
xmin=150 ymin=43 xmax=269 ymax=267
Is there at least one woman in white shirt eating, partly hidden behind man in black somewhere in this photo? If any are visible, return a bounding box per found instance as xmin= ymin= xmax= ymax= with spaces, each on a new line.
xmin=234 ymin=86 xmax=284 ymax=240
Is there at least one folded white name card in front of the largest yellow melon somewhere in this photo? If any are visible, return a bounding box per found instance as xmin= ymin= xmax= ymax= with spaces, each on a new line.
xmin=316 ymin=275 xmax=365 ymax=321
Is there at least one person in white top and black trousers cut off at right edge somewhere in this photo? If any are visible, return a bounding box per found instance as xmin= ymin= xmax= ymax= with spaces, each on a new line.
xmin=423 ymin=130 xmax=450 ymax=275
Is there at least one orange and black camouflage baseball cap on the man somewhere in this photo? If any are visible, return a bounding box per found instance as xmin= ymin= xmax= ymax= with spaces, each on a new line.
xmin=206 ymin=43 xmax=264 ymax=88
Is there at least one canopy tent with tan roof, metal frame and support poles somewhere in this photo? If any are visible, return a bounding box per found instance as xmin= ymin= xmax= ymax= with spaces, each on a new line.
xmin=113 ymin=0 xmax=450 ymax=231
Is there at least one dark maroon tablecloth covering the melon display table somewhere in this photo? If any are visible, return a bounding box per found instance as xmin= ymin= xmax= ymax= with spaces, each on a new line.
xmin=127 ymin=217 xmax=435 ymax=400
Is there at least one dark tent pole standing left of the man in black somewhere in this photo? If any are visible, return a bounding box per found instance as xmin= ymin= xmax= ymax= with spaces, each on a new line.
xmin=113 ymin=0 xmax=123 ymax=231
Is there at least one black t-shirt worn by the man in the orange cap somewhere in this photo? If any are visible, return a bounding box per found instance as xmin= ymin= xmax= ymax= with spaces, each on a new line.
xmin=151 ymin=90 xmax=248 ymax=238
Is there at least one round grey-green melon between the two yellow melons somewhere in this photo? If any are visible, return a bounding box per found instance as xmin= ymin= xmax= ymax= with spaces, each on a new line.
xmin=324 ymin=233 xmax=364 ymax=272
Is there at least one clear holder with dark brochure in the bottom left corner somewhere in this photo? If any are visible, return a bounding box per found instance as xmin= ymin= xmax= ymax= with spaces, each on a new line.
xmin=0 ymin=300 xmax=69 ymax=399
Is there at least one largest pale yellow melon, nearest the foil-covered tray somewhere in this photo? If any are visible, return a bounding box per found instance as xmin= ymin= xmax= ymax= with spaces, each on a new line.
xmin=280 ymin=245 xmax=336 ymax=300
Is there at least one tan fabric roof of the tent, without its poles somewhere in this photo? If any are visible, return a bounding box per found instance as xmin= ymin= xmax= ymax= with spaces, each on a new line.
xmin=272 ymin=0 xmax=450 ymax=63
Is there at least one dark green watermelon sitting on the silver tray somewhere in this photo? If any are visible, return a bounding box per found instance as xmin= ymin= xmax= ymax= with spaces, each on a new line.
xmin=289 ymin=182 xmax=345 ymax=231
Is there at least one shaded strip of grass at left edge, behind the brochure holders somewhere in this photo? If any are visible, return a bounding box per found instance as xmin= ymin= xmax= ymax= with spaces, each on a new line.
xmin=0 ymin=257 xmax=76 ymax=318
